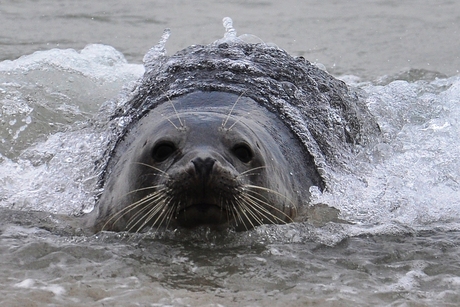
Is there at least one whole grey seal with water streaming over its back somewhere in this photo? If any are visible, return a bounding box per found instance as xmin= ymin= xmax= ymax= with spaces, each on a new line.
xmin=84 ymin=21 xmax=379 ymax=232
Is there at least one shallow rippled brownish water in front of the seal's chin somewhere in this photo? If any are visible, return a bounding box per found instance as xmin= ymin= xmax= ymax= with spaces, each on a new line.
xmin=1 ymin=228 xmax=460 ymax=306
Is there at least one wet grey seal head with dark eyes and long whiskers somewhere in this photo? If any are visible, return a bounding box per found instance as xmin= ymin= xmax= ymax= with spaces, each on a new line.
xmin=88 ymin=91 xmax=322 ymax=231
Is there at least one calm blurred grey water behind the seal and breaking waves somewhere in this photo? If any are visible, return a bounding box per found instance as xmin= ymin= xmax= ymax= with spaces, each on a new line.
xmin=0 ymin=0 xmax=460 ymax=79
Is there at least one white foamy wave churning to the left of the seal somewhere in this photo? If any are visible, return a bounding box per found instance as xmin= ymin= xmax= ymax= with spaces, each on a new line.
xmin=0 ymin=45 xmax=144 ymax=213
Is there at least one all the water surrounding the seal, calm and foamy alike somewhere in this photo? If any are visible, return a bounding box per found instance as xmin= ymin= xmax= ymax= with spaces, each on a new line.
xmin=0 ymin=1 xmax=460 ymax=306
